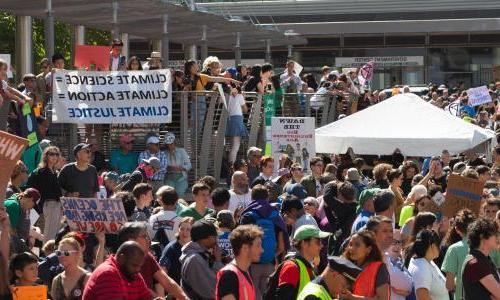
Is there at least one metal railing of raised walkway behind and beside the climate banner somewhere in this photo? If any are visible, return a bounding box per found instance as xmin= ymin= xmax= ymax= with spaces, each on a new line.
xmin=47 ymin=92 xmax=338 ymax=182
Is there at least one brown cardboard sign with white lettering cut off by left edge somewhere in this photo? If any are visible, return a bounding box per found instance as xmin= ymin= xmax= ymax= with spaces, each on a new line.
xmin=0 ymin=131 xmax=28 ymax=206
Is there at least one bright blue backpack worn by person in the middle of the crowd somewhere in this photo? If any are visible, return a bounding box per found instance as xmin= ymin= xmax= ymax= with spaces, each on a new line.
xmin=248 ymin=209 xmax=279 ymax=264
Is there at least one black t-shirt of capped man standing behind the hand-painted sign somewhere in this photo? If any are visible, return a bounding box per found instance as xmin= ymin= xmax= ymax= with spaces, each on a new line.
xmin=57 ymin=163 xmax=99 ymax=198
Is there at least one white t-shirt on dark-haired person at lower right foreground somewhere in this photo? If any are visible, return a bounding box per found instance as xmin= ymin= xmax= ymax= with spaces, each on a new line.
xmin=408 ymin=258 xmax=450 ymax=300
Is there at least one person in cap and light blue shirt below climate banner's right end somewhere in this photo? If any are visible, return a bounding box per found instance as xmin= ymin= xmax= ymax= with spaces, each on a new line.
xmin=165 ymin=132 xmax=192 ymax=198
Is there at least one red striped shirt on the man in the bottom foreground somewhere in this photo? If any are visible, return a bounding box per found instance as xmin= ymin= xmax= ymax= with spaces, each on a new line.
xmin=82 ymin=255 xmax=152 ymax=300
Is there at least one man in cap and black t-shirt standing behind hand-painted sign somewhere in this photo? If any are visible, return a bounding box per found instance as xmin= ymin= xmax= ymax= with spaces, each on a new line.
xmin=57 ymin=143 xmax=99 ymax=198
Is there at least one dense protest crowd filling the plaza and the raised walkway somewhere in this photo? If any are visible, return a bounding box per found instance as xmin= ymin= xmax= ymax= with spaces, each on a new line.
xmin=0 ymin=40 xmax=500 ymax=300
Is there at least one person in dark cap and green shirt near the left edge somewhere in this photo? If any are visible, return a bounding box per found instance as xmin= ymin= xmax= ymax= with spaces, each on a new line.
xmin=4 ymin=188 xmax=40 ymax=253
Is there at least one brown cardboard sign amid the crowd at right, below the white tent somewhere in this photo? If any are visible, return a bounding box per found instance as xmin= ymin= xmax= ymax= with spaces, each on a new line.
xmin=441 ymin=173 xmax=483 ymax=218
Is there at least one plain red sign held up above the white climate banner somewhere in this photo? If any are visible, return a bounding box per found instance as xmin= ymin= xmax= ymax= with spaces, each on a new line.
xmin=75 ymin=45 xmax=110 ymax=71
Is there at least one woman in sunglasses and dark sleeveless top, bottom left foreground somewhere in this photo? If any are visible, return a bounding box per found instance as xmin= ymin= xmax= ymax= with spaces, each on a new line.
xmin=51 ymin=237 xmax=90 ymax=300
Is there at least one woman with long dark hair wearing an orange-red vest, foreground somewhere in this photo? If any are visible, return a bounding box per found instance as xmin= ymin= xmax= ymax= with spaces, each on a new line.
xmin=342 ymin=230 xmax=391 ymax=300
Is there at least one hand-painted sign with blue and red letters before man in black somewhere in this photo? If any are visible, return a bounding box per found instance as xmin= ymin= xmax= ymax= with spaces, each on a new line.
xmin=61 ymin=197 xmax=127 ymax=233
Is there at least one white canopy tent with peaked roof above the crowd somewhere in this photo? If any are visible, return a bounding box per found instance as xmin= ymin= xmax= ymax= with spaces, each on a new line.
xmin=316 ymin=94 xmax=494 ymax=157
